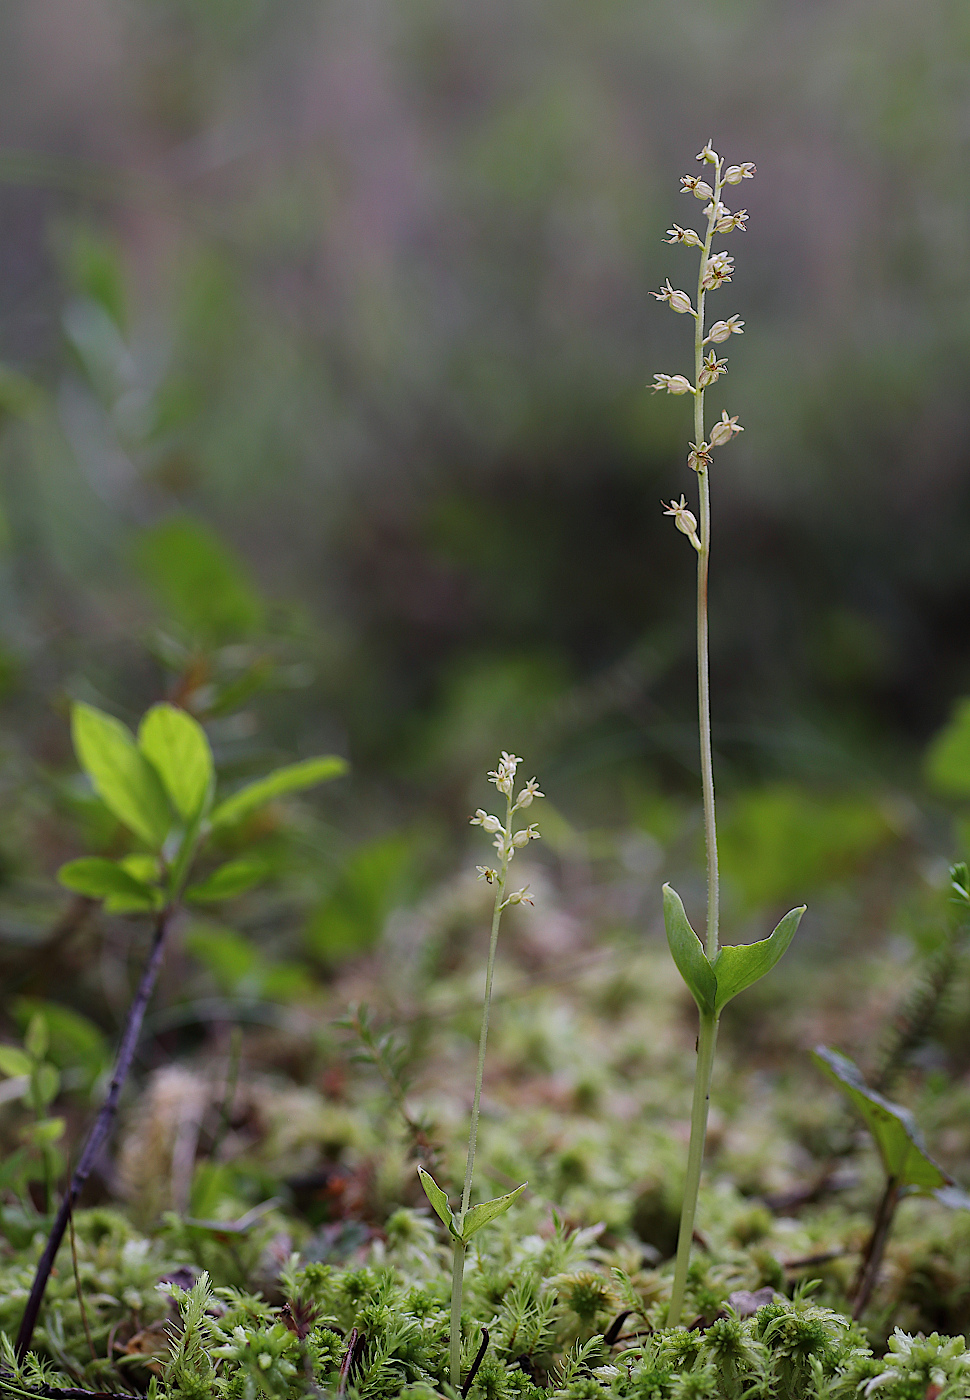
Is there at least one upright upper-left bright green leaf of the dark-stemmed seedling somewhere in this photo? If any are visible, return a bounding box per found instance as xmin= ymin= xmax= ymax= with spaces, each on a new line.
xmin=71 ymin=703 xmax=172 ymax=850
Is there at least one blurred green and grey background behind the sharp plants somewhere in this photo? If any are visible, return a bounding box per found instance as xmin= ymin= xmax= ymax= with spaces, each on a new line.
xmin=0 ymin=0 xmax=970 ymax=963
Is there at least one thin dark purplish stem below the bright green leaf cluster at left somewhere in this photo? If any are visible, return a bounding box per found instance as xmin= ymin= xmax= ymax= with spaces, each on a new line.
xmin=17 ymin=904 xmax=175 ymax=1361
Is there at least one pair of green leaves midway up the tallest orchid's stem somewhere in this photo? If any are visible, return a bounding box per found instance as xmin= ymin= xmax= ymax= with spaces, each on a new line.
xmin=663 ymin=885 xmax=805 ymax=1016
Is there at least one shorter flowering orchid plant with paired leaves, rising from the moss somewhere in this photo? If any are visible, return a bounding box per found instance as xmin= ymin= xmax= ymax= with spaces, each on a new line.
xmin=417 ymin=752 xmax=544 ymax=1390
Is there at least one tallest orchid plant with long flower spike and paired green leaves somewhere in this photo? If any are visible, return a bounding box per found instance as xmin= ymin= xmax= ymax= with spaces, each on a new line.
xmin=651 ymin=141 xmax=805 ymax=1327
